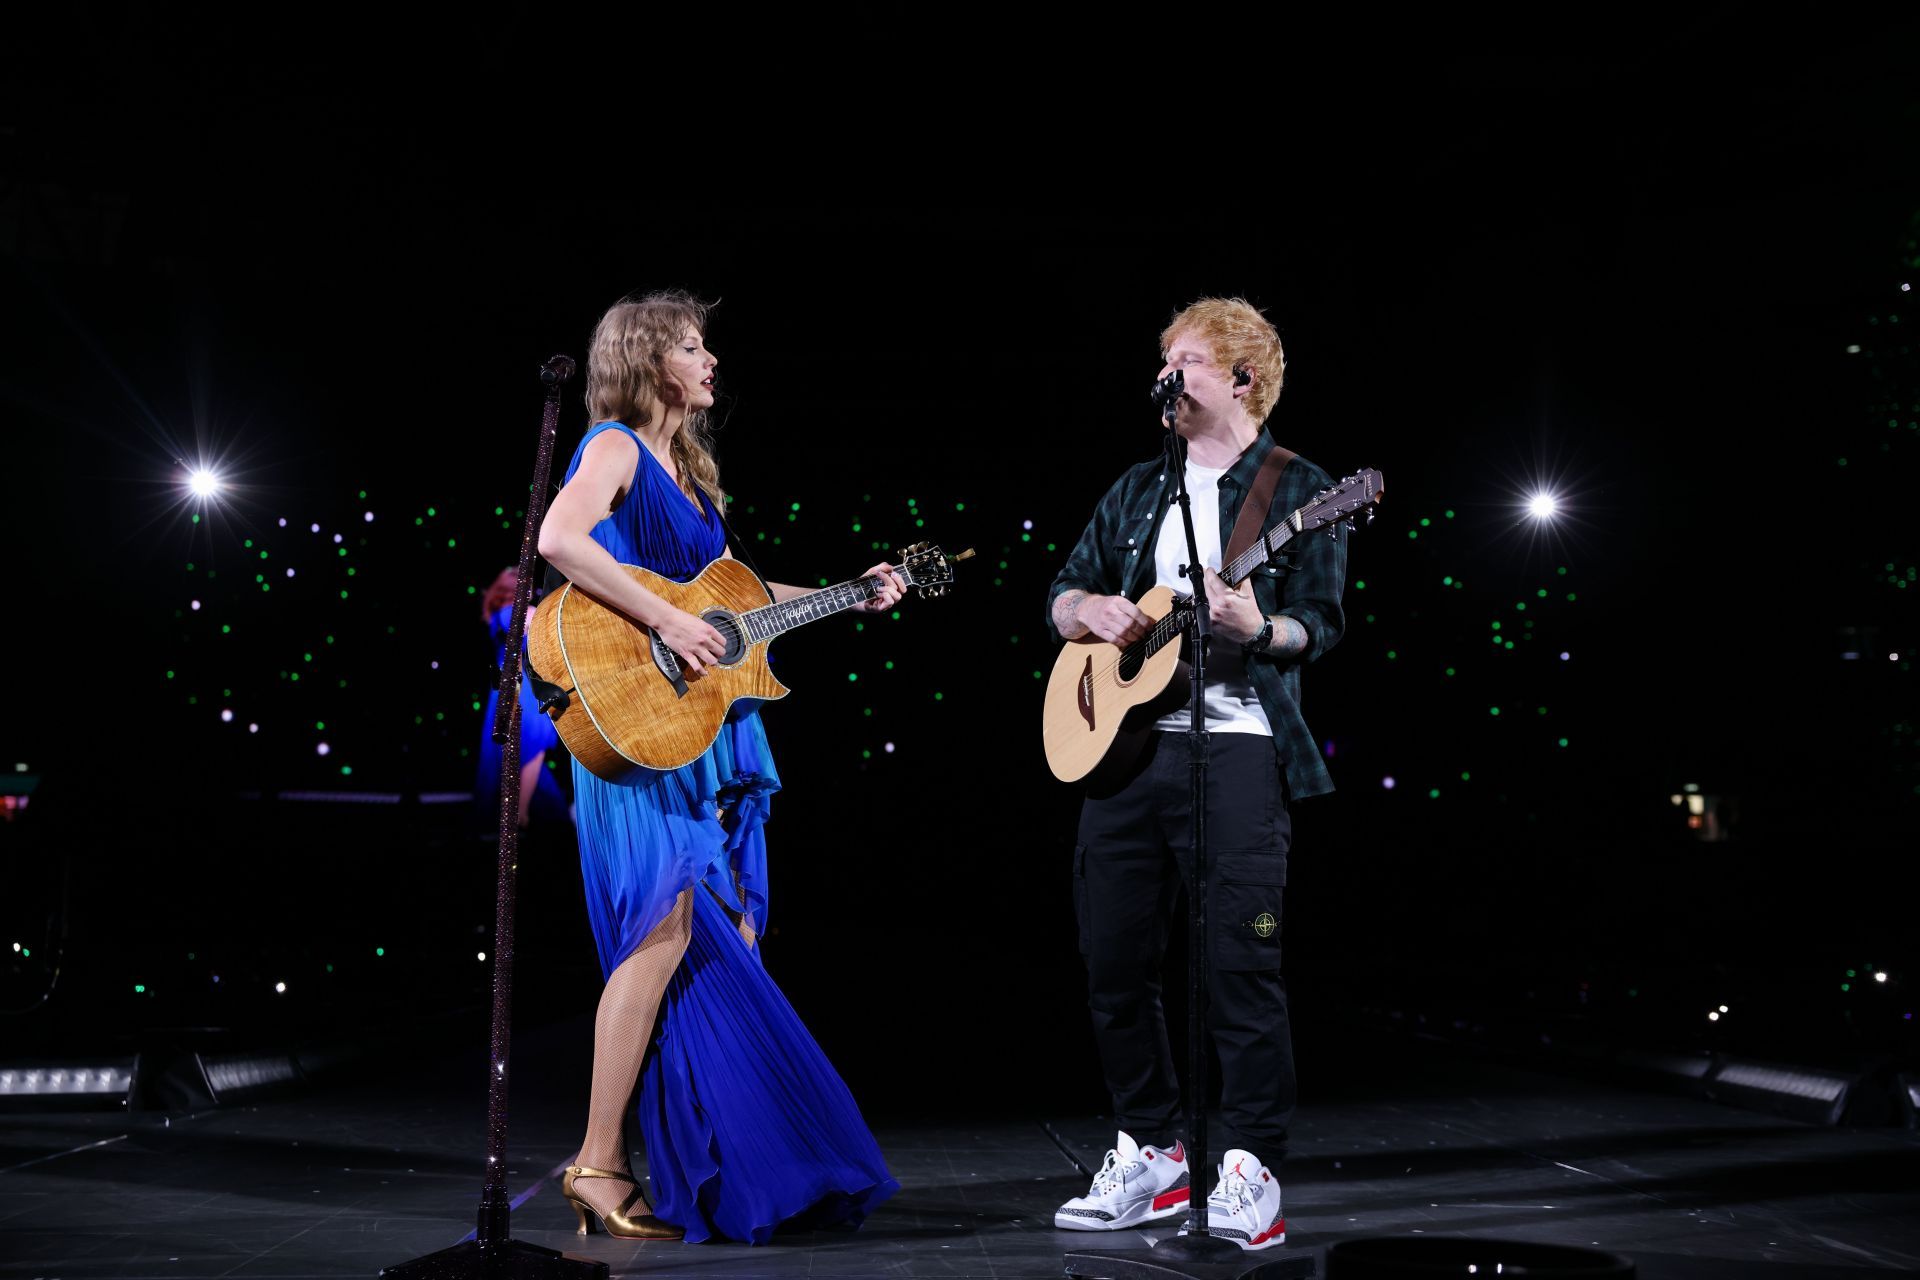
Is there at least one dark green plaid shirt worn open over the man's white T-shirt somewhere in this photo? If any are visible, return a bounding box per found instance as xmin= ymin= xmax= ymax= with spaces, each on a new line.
xmin=1046 ymin=428 xmax=1346 ymax=798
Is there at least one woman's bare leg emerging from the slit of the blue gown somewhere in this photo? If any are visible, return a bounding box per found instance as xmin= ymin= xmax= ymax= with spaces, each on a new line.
xmin=574 ymin=889 xmax=693 ymax=1213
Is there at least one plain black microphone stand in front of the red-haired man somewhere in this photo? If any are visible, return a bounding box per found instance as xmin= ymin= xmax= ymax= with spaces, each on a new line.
xmin=1066 ymin=368 xmax=1315 ymax=1280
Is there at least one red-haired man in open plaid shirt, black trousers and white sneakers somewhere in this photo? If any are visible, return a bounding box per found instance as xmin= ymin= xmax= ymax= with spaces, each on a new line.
xmin=1048 ymin=297 xmax=1346 ymax=1249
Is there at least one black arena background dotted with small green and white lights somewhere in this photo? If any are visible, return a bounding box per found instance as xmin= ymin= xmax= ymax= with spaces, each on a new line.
xmin=0 ymin=6 xmax=1920 ymax=1109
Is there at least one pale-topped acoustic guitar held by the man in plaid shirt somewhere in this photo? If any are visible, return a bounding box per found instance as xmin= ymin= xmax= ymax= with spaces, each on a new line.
xmin=1041 ymin=470 xmax=1386 ymax=791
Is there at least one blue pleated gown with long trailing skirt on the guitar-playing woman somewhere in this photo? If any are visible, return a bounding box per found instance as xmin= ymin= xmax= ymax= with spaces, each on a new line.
xmin=566 ymin=422 xmax=899 ymax=1244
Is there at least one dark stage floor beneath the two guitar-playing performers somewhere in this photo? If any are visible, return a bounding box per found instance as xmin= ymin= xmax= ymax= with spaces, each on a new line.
xmin=0 ymin=1023 xmax=1920 ymax=1280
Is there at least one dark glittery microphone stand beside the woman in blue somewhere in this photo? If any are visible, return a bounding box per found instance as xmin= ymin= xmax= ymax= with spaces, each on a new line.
xmin=380 ymin=355 xmax=607 ymax=1280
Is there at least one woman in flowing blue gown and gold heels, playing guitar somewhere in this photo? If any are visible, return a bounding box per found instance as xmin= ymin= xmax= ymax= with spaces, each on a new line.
xmin=540 ymin=292 xmax=902 ymax=1244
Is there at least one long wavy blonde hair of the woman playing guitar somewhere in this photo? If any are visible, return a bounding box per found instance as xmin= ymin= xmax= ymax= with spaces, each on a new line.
xmin=588 ymin=290 xmax=726 ymax=507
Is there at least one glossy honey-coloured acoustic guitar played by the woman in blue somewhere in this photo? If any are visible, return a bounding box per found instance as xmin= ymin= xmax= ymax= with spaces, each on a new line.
xmin=526 ymin=543 xmax=973 ymax=781
